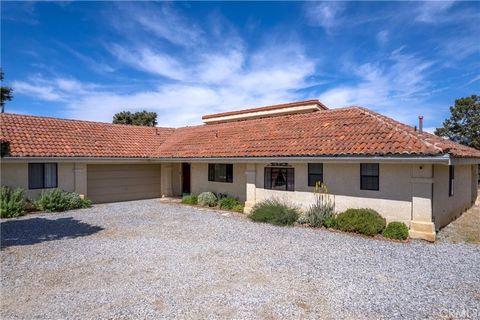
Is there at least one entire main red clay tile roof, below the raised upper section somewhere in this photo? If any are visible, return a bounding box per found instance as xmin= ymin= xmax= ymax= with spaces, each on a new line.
xmin=0 ymin=107 xmax=480 ymax=158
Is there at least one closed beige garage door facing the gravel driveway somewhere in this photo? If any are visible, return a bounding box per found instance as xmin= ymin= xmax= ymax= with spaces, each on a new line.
xmin=87 ymin=164 xmax=161 ymax=203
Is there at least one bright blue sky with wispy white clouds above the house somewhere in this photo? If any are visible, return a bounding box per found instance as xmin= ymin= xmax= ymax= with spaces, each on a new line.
xmin=1 ymin=1 xmax=480 ymax=130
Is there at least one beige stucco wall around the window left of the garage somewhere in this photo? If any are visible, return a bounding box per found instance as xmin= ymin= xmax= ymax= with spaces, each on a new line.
xmin=0 ymin=163 xmax=75 ymax=199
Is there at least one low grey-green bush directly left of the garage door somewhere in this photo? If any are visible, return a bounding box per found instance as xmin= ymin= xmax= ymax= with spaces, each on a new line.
xmin=35 ymin=189 xmax=92 ymax=212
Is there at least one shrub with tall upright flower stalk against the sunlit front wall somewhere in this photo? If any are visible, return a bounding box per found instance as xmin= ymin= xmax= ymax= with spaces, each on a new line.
xmin=304 ymin=182 xmax=335 ymax=227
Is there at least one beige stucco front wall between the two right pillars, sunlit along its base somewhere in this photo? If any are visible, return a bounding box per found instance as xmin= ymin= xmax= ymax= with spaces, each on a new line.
xmin=256 ymin=163 xmax=413 ymax=224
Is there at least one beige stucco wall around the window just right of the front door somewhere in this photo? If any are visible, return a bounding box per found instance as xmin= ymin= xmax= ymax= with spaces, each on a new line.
xmin=191 ymin=163 xmax=246 ymax=201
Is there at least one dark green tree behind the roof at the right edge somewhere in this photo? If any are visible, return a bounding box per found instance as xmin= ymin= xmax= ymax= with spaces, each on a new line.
xmin=435 ymin=95 xmax=480 ymax=150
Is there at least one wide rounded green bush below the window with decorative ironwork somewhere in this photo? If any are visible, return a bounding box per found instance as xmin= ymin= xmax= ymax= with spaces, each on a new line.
xmin=248 ymin=199 xmax=299 ymax=225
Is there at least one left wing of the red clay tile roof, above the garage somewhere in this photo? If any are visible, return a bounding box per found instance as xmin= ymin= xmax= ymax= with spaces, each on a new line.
xmin=0 ymin=113 xmax=175 ymax=158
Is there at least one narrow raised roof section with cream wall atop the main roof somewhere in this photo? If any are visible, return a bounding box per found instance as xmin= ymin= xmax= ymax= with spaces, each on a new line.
xmin=202 ymin=100 xmax=328 ymax=124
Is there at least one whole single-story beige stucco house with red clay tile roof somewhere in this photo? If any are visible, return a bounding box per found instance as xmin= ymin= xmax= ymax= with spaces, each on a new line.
xmin=0 ymin=100 xmax=480 ymax=240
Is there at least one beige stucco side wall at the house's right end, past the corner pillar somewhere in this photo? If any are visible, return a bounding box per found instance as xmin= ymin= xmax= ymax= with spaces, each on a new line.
xmin=433 ymin=165 xmax=474 ymax=229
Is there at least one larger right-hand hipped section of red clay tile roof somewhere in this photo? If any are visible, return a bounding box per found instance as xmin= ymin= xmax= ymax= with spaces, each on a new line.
xmin=158 ymin=107 xmax=480 ymax=157
